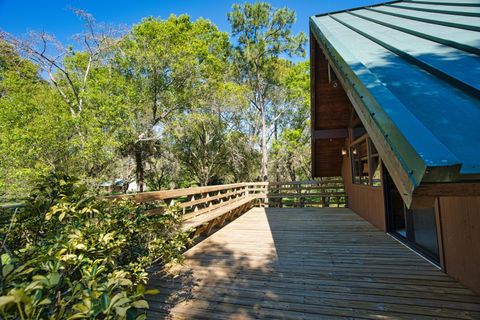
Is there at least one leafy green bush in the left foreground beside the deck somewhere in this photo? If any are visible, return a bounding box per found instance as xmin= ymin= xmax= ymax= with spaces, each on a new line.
xmin=0 ymin=174 xmax=190 ymax=319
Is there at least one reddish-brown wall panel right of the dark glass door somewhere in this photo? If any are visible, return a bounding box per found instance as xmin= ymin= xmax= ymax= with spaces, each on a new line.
xmin=438 ymin=196 xmax=480 ymax=294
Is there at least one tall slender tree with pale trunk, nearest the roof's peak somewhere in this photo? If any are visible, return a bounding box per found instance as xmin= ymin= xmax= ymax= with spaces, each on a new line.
xmin=228 ymin=3 xmax=306 ymax=181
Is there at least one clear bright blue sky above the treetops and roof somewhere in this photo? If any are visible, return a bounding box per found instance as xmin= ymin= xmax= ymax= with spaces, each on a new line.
xmin=0 ymin=0 xmax=383 ymax=44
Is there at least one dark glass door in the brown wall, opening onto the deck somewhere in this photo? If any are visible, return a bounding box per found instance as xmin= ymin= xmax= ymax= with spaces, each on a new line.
xmin=383 ymin=167 xmax=439 ymax=264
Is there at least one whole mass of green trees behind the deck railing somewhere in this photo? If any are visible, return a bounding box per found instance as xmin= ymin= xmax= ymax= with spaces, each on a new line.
xmin=0 ymin=3 xmax=309 ymax=202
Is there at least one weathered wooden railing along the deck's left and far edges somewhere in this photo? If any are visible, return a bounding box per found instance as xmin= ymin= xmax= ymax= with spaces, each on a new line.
xmin=108 ymin=179 xmax=347 ymax=234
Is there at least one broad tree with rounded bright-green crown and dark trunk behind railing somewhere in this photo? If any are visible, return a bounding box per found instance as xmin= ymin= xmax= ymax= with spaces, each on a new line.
xmin=117 ymin=15 xmax=229 ymax=191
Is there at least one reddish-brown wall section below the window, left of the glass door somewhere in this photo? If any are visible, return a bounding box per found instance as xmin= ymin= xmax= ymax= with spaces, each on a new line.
xmin=342 ymin=152 xmax=387 ymax=232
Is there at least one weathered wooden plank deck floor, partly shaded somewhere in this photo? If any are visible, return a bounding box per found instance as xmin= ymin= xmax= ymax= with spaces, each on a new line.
xmin=149 ymin=208 xmax=480 ymax=319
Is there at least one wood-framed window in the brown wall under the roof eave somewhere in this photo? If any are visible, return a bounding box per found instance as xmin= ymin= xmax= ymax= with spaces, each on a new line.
xmin=350 ymin=135 xmax=382 ymax=187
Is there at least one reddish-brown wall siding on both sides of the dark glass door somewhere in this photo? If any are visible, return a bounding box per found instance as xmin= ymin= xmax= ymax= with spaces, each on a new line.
xmin=342 ymin=146 xmax=480 ymax=295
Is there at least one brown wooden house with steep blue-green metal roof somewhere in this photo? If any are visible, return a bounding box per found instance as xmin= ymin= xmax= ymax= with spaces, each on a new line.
xmin=310 ymin=0 xmax=480 ymax=293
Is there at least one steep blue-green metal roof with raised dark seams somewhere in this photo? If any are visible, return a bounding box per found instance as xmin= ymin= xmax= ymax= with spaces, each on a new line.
xmin=310 ymin=0 xmax=480 ymax=186
